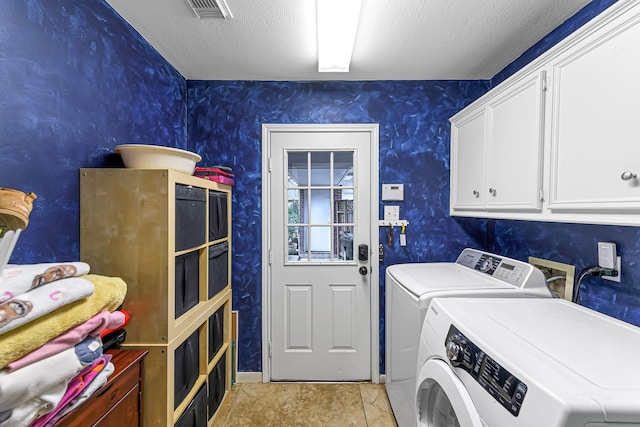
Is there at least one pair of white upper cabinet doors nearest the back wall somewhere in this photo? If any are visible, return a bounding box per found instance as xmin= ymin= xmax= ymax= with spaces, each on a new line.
xmin=451 ymin=72 xmax=544 ymax=211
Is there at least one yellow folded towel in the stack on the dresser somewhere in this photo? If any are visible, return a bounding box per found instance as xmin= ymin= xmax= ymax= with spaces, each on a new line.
xmin=0 ymin=274 xmax=127 ymax=368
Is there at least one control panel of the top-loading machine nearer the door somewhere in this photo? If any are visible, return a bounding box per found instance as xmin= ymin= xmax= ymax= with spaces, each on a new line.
xmin=456 ymin=248 xmax=545 ymax=287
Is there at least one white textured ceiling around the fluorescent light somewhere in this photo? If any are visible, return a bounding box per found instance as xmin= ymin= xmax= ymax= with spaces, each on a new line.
xmin=107 ymin=0 xmax=589 ymax=80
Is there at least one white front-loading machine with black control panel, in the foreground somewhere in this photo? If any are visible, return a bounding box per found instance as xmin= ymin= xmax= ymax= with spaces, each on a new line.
xmin=415 ymin=298 xmax=640 ymax=427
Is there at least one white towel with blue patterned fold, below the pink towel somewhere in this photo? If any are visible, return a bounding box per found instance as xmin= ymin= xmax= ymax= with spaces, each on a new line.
xmin=0 ymin=337 xmax=102 ymax=411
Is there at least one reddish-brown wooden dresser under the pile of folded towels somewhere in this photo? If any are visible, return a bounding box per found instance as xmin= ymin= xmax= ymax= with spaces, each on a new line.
xmin=56 ymin=350 xmax=147 ymax=427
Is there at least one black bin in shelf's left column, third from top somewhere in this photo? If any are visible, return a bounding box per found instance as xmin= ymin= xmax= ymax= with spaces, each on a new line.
xmin=173 ymin=330 xmax=200 ymax=409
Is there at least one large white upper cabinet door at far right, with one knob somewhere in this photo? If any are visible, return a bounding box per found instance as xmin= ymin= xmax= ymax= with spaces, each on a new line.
xmin=549 ymin=3 xmax=640 ymax=213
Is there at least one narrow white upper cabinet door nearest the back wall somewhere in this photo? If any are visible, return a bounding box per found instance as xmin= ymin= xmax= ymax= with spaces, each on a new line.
xmin=451 ymin=107 xmax=485 ymax=210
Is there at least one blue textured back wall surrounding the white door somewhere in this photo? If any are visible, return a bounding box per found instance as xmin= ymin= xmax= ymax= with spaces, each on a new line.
xmin=187 ymin=81 xmax=488 ymax=371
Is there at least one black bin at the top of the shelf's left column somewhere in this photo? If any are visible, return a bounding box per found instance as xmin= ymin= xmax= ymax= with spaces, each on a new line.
xmin=176 ymin=184 xmax=207 ymax=251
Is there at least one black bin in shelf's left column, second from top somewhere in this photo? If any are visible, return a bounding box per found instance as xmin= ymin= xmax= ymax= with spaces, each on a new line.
xmin=175 ymin=251 xmax=200 ymax=319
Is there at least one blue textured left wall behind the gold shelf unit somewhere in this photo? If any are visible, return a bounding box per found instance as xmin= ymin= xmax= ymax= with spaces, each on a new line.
xmin=0 ymin=0 xmax=186 ymax=263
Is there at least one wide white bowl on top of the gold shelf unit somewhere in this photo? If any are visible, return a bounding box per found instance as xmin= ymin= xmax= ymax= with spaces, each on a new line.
xmin=115 ymin=144 xmax=202 ymax=175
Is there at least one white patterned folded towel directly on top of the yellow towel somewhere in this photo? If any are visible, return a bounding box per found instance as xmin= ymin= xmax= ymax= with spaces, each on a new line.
xmin=0 ymin=277 xmax=94 ymax=334
